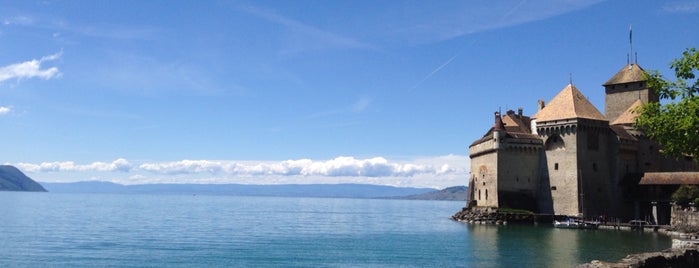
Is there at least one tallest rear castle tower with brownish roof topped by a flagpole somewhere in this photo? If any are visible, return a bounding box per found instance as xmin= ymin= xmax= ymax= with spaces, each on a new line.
xmin=603 ymin=63 xmax=658 ymax=121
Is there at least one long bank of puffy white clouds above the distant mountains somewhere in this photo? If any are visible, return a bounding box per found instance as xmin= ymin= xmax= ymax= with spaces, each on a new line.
xmin=14 ymin=155 xmax=468 ymax=188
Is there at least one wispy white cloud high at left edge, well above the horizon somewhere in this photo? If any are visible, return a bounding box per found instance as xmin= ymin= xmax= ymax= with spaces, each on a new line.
xmin=0 ymin=52 xmax=62 ymax=82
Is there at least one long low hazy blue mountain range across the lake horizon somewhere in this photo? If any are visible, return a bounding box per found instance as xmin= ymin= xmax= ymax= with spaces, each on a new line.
xmin=42 ymin=181 xmax=466 ymax=200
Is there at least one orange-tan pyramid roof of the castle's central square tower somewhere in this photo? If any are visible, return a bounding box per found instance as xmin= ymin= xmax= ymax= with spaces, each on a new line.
xmin=532 ymin=84 xmax=607 ymax=122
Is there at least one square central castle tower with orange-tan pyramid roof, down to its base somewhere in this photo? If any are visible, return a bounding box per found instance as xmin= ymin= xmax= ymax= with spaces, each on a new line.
xmin=532 ymin=84 xmax=611 ymax=216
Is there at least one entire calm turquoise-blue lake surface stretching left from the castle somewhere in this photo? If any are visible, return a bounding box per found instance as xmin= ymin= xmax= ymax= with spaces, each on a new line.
xmin=0 ymin=192 xmax=671 ymax=267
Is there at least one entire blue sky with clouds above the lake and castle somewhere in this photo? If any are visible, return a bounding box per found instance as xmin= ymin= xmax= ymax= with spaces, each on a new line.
xmin=0 ymin=0 xmax=699 ymax=188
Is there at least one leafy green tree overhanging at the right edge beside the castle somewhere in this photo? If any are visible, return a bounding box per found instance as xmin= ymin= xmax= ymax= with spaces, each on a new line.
xmin=636 ymin=48 xmax=699 ymax=161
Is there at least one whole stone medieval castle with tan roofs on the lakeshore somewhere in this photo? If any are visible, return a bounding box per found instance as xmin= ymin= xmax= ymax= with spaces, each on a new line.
xmin=469 ymin=64 xmax=697 ymax=223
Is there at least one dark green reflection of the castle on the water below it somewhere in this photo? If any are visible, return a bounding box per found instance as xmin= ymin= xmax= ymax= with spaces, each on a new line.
xmin=467 ymin=225 xmax=671 ymax=267
